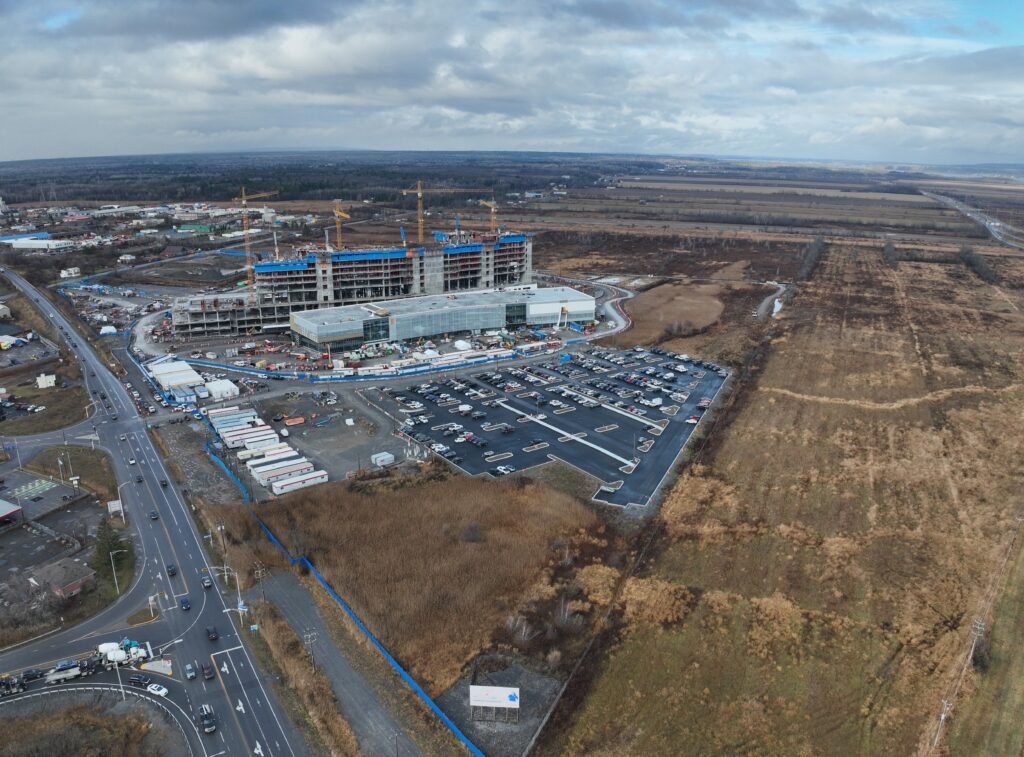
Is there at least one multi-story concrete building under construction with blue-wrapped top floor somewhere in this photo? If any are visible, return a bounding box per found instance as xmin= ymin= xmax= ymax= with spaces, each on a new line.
xmin=171 ymin=233 xmax=534 ymax=337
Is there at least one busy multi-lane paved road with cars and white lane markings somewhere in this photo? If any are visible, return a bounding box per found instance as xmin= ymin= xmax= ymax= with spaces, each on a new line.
xmin=0 ymin=272 xmax=307 ymax=757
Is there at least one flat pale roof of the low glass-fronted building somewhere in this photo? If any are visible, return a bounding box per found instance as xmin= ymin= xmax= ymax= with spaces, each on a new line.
xmin=292 ymin=287 xmax=593 ymax=327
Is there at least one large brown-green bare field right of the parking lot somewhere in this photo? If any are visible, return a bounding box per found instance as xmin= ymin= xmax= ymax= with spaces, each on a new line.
xmin=548 ymin=246 xmax=1024 ymax=755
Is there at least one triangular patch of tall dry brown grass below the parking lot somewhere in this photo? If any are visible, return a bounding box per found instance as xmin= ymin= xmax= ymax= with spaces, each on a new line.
xmin=261 ymin=478 xmax=596 ymax=691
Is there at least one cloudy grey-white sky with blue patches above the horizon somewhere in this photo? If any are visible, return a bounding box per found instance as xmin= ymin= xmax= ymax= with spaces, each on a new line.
xmin=0 ymin=0 xmax=1024 ymax=163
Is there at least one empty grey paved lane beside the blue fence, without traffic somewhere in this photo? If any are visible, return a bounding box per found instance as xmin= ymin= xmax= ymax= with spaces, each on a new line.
xmin=250 ymin=571 xmax=420 ymax=757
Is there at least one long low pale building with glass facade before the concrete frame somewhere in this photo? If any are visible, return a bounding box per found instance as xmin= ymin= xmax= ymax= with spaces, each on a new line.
xmin=291 ymin=287 xmax=595 ymax=348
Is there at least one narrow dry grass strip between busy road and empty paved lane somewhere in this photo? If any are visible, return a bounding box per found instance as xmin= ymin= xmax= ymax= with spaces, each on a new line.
xmin=253 ymin=602 xmax=359 ymax=757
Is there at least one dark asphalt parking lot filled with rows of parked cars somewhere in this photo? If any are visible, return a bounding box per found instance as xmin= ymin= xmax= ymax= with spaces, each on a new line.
xmin=381 ymin=347 xmax=728 ymax=507
